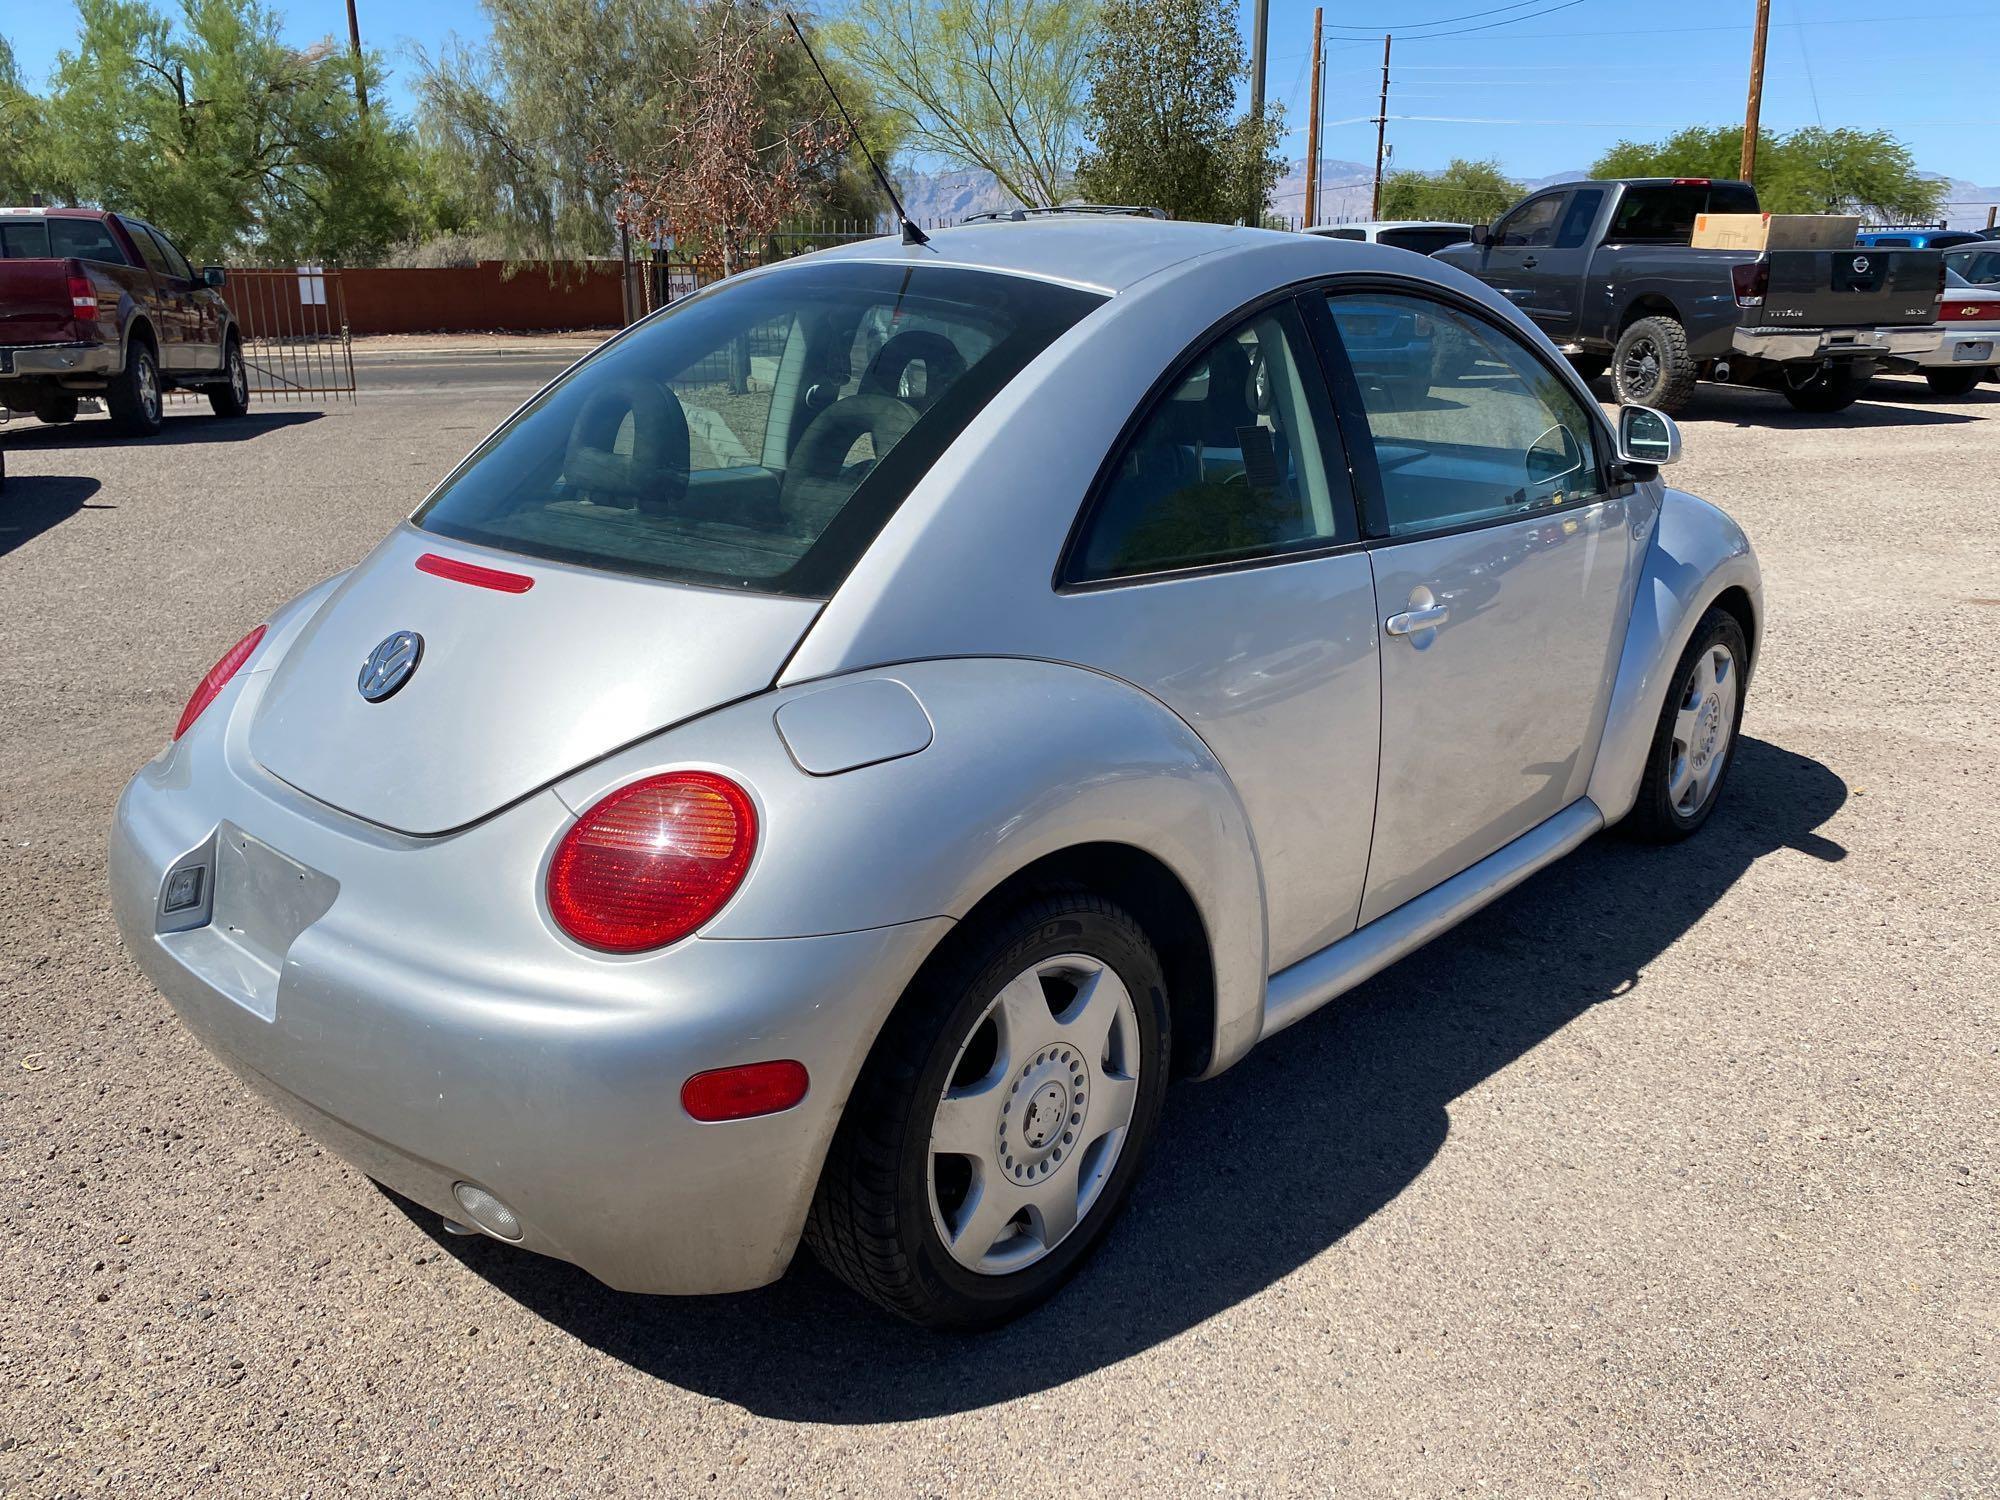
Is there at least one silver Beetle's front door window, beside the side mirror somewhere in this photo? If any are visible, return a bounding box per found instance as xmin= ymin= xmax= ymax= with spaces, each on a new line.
xmin=1328 ymin=292 xmax=1606 ymax=536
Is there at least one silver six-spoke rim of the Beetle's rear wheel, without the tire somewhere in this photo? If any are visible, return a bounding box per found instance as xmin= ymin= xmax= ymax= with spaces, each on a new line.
xmin=928 ymin=954 xmax=1142 ymax=1276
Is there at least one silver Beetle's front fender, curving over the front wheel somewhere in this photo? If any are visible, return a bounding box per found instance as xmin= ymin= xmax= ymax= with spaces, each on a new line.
xmin=1588 ymin=490 xmax=1764 ymax=824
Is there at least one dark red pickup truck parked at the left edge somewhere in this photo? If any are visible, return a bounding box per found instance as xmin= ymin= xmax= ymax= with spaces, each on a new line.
xmin=0 ymin=208 xmax=250 ymax=436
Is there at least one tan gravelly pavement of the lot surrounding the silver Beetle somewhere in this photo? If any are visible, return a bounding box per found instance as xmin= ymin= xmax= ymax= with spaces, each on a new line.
xmin=0 ymin=370 xmax=2000 ymax=1496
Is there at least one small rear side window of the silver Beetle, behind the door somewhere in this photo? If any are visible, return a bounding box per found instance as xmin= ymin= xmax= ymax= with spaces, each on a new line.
xmin=1068 ymin=302 xmax=1356 ymax=582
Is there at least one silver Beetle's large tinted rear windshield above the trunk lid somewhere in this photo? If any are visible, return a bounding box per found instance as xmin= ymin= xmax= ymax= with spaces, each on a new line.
xmin=414 ymin=262 xmax=1104 ymax=598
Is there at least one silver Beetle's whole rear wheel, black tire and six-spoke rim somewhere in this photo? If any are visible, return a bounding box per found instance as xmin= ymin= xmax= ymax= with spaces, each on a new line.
xmin=806 ymin=890 xmax=1172 ymax=1330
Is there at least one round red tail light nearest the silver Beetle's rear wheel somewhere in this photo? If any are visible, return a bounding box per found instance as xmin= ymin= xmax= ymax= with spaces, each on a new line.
xmin=548 ymin=770 xmax=756 ymax=954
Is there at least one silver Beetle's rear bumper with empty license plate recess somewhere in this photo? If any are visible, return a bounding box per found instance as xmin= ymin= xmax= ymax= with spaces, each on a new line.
xmin=110 ymin=684 xmax=950 ymax=1292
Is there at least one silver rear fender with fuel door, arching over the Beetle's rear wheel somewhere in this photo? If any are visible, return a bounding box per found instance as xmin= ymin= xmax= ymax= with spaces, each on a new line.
xmin=556 ymin=658 xmax=1266 ymax=1072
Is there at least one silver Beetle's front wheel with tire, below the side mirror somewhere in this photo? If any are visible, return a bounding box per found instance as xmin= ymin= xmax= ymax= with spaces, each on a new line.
xmin=1624 ymin=608 xmax=1750 ymax=844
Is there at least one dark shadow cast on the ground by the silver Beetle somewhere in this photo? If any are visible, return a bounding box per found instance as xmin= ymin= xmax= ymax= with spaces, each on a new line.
xmin=404 ymin=740 xmax=1846 ymax=1424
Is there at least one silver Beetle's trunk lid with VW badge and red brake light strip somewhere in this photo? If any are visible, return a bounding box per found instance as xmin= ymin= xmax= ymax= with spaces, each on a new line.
xmin=250 ymin=526 xmax=820 ymax=834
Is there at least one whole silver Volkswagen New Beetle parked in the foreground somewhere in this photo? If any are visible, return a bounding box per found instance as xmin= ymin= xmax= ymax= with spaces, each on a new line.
xmin=112 ymin=214 xmax=1762 ymax=1326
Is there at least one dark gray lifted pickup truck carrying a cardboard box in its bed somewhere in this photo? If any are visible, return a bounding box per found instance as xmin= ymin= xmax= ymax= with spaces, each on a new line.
xmin=1436 ymin=178 xmax=1944 ymax=412
